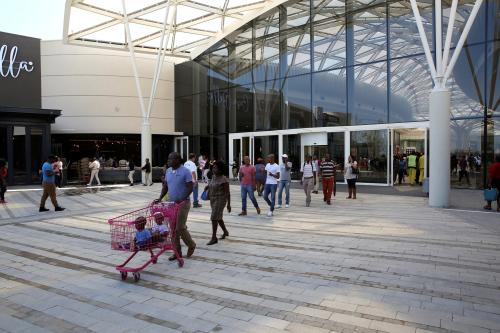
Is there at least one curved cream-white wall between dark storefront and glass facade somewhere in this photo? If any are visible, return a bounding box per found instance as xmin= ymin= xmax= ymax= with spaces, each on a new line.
xmin=41 ymin=41 xmax=175 ymax=134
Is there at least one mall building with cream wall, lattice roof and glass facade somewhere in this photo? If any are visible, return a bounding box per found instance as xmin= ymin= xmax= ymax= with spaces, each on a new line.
xmin=0 ymin=0 xmax=500 ymax=195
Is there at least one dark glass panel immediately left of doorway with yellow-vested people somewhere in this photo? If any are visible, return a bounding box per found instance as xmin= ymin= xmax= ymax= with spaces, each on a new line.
xmin=351 ymin=130 xmax=387 ymax=184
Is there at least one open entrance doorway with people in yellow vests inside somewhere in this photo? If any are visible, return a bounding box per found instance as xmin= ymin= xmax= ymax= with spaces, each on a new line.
xmin=390 ymin=128 xmax=427 ymax=185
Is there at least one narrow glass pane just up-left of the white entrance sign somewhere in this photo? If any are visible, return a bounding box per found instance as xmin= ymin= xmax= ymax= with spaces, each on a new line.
xmin=283 ymin=74 xmax=312 ymax=129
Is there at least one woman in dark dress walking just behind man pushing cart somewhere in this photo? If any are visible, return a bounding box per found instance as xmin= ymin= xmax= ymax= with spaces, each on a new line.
xmin=207 ymin=161 xmax=231 ymax=245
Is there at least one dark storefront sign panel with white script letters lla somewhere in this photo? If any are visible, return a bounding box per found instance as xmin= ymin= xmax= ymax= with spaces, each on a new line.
xmin=0 ymin=32 xmax=42 ymax=109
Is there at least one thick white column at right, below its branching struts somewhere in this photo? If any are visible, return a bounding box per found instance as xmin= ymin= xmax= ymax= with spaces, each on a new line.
xmin=429 ymin=87 xmax=451 ymax=207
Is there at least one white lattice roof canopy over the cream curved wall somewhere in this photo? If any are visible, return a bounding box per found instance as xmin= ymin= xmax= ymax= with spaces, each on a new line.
xmin=64 ymin=0 xmax=285 ymax=58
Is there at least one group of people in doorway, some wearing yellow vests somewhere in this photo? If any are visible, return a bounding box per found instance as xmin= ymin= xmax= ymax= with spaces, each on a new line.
xmin=393 ymin=151 xmax=425 ymax=186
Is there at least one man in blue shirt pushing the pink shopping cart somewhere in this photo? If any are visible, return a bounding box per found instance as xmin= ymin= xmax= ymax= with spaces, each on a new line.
xmin=158 ymin=153 xmax=196 ymax=261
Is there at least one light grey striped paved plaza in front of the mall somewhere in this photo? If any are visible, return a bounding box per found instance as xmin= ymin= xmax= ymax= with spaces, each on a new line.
xmin=0 ymin=184 xmax=500 ymax=333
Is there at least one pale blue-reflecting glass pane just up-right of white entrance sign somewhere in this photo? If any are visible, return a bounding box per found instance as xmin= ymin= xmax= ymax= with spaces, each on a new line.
xmin=312 ymin=69 xmax=347 ymax=127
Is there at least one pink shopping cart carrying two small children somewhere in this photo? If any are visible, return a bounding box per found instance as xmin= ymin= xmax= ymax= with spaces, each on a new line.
xmin=108 ymin=202 xmax=184 ymax=282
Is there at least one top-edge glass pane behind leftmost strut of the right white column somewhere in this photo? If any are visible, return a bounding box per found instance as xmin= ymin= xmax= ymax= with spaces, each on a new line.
xmin=389 ymin=0 xmax=434 ymax=58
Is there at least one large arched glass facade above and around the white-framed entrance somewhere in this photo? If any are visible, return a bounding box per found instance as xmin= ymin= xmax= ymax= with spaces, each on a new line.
xmin=175 ymin=0 xmax=500 ymax=187
